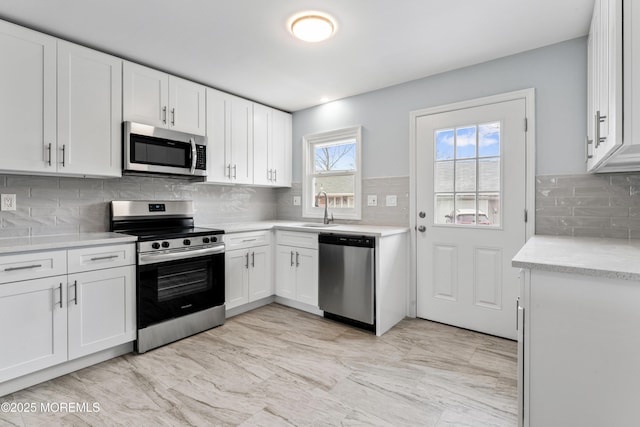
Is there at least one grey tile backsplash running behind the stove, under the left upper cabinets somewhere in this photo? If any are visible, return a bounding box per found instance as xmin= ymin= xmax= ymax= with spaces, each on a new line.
xmin=0 ymin=175 xmax=276 ymax=237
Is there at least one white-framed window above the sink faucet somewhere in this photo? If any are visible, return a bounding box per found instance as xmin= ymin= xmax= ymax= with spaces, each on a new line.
xmin=302 ymin=126 xmax=362 ymax=219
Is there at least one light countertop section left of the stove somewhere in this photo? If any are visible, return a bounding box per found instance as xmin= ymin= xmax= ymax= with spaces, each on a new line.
xmin=0 ymin=232 xmax=138 ymax=254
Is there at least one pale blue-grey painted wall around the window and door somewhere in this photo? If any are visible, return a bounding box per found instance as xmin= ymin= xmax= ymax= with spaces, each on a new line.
xmin=293 ymin=37 xmax=587 ymax=182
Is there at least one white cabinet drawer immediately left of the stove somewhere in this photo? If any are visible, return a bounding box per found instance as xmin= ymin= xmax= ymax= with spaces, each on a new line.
xmin=68 ymin=244 xmax=136 ymax=273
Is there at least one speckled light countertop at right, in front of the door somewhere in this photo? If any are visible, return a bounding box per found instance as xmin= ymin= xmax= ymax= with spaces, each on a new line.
xmin=512 ymin=236 xmax=640 ymax=280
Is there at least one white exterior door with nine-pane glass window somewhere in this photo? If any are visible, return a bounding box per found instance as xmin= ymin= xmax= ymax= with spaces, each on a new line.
xmin=415 ymin=98 xmax=526 ymax=339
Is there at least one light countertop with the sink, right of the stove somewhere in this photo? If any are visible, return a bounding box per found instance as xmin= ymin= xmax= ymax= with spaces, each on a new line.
xmin=198 ymin=221 xmax=409 ymax=237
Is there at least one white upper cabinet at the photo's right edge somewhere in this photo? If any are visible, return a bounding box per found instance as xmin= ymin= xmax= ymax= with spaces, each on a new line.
xmin=587 ymin=0 xmax=640 ymax=172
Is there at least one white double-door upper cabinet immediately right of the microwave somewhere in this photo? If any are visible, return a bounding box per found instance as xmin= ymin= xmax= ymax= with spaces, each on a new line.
xmin=207 ymin=88 xmax=253 ymax=184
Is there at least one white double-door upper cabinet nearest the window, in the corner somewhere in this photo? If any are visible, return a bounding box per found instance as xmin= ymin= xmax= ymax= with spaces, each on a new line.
xmin=253 ymin=104 xmax=291 ymax=187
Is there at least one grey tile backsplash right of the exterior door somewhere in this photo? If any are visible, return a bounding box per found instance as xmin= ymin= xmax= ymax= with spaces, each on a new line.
xmin=536 ymin=173 xmax=640 ymax=239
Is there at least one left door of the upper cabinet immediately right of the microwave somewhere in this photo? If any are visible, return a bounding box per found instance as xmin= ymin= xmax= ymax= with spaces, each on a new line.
xmin=206 ymin=88 xmax=231 ymax=183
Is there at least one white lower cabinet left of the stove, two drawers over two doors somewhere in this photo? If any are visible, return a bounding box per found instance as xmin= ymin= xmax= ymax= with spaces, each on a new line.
xmin=0 ymin=244 xmax=136 ymax=383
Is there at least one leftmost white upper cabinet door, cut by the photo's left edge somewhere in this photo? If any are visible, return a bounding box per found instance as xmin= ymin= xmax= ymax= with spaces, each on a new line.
xmin=0 ymin=22 xmax=56 ymax=172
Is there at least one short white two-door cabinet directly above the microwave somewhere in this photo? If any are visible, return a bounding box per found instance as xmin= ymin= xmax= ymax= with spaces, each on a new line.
xmin=122 ymin=62 xmax=206 ymax=135
